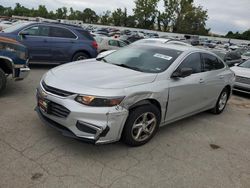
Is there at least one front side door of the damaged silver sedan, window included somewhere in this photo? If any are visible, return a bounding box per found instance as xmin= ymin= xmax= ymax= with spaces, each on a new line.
xmin=166 ymin=52 xmax=205 ymax=121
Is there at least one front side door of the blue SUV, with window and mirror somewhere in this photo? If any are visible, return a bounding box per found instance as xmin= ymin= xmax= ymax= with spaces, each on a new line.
xmin=19 ymin=24 xmax=52 ymax=62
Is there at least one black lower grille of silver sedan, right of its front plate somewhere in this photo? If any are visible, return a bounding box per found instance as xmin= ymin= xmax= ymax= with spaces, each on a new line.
xmin=49 ymin=101 xmax=70 ymax=118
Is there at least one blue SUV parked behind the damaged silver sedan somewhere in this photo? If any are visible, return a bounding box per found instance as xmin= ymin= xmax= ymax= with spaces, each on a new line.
xmin=0 ymin=22 xmax=97 ymax=63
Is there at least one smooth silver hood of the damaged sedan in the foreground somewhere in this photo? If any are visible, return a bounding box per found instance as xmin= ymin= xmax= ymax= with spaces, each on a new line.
xmin=44 ymin=59 xmax=157 ymax=91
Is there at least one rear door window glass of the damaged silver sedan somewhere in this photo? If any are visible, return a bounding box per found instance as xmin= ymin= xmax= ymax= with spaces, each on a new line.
xmin=202 ymin=54 xmax=225 ymax=71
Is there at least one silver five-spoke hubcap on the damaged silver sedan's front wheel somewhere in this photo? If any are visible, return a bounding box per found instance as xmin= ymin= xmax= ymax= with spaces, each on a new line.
xmin=132 ymin=112 xmax=157 ymax=142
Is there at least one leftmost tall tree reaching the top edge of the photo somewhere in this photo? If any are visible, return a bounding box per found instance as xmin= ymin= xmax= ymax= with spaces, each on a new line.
xmin=133 ymin=0 xmax=159 ymax=29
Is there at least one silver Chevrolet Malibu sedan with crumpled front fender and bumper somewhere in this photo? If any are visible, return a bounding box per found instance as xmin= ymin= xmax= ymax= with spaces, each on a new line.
xmin=36 ymin=44 xmax=235 ymax=146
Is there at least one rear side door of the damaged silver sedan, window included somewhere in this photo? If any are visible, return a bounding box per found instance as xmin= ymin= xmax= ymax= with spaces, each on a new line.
xmin=202 ymin=53 xmax=227 ymax=106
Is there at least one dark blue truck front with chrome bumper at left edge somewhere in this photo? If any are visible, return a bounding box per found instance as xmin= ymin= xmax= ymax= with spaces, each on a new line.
xmin=0 ymin=37 xmax=30 ymax=93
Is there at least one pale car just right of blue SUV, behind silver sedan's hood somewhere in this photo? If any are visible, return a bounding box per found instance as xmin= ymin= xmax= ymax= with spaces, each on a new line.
xmin=96 ymin=37 xmax=127 ymax=53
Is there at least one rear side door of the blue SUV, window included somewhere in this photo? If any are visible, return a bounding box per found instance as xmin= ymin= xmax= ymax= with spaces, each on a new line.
xmin=49 ymin=26 xmax=77 ymax=62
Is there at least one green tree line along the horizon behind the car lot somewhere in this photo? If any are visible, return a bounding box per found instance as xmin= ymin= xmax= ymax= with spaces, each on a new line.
xmin=0 ymin=0 xmax=214 ymax=38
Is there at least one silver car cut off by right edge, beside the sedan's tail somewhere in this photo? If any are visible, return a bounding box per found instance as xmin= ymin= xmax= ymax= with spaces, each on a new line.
xmin=231 ymin=60 xmax=250 ymax=94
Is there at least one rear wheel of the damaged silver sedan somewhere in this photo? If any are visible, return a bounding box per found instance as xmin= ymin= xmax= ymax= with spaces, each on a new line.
xmin=212 ymin=88 xmax=229 ymax=114
